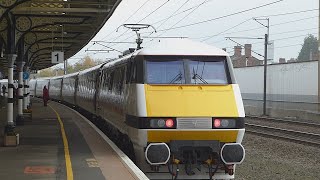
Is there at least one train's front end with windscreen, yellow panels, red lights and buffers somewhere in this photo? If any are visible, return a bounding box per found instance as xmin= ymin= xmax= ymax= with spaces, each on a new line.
xmin=125 ymin=47 xmax=245 ymax=178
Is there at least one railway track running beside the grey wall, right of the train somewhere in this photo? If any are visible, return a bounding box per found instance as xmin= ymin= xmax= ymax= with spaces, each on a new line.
xmin=245 ymin=117 xmax=320 ymax=146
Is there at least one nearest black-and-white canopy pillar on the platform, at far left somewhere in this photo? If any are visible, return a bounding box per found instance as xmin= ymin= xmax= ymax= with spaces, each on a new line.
xmin=7 ymin=54 xmax=17 ymax=128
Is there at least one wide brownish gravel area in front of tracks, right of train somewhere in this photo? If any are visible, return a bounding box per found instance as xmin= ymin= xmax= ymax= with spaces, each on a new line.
xmin=235 ymin=133 xmax=320 ymax=180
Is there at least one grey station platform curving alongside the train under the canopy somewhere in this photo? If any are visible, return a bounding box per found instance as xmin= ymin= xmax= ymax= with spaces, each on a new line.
xmin=0 ymin=98 xmax=143 ymax=180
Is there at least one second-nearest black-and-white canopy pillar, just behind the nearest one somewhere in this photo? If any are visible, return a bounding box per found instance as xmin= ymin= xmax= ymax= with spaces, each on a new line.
xmin=16 ymin=61 xmax=25 ymax=125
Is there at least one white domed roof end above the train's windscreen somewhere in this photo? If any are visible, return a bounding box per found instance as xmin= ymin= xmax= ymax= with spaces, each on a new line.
xmin=135 ymin=38 xmax=228 ymax=56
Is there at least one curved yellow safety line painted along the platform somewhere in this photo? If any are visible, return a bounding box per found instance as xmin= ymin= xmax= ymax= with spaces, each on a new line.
xmin=48 ymin=105 xmax=73 ymax=180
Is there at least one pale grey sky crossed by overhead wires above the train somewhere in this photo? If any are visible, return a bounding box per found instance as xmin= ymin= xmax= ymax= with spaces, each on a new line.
xmin=62 ymin=0 xmax=319 ymax=66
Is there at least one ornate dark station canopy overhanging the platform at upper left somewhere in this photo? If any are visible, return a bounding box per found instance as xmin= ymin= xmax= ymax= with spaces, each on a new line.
xmin=0 ymin=0 xmax=121 ymax=75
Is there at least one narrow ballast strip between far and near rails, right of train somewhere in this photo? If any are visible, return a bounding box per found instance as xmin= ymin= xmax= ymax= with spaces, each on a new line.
xmin=245 ymin=118 xmax=320 ymax=134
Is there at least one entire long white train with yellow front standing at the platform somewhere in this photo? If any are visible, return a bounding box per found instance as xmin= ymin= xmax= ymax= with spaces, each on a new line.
xmin=30 ymin=39 xmax=245 ymax=179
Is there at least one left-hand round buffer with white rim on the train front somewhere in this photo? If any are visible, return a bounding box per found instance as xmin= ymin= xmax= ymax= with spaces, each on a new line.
xmin=145 ymin=143 xmax=170 ymax=165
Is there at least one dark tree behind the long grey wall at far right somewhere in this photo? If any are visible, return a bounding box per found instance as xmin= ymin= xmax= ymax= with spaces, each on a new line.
xmin=298 ymin=34 xmax=318 ymax=61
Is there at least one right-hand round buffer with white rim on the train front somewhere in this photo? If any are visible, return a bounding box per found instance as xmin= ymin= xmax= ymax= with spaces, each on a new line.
xmin=220 ymin=143 xmax=245 ymax=164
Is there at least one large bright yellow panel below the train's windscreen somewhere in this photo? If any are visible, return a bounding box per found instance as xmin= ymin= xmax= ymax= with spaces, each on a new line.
xmin=145 ymin=85 xmax=239 ymax=117
